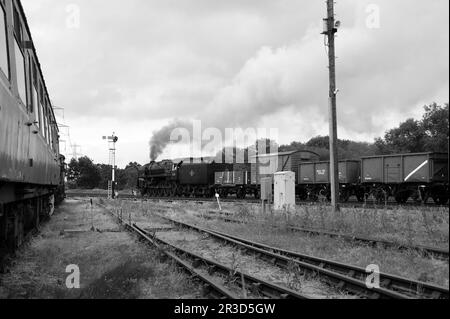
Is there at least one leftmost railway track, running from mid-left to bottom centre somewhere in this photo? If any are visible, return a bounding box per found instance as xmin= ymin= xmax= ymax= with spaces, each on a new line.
xmin=99 ymin=205 xmax=308 ymax=299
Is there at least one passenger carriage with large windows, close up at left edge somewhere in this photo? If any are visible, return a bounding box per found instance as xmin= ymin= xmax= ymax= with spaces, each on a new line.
xmin=0 ymin=0 xmax=65 ymax=261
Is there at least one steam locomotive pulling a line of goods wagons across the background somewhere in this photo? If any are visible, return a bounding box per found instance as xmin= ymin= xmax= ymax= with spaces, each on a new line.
xmin=139 ymin=151 xmax=448 ymax=205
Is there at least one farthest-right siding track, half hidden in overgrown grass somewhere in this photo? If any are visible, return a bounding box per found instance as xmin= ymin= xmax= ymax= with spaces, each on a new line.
xmin=197 ymin=213 xmax=449 ymax=261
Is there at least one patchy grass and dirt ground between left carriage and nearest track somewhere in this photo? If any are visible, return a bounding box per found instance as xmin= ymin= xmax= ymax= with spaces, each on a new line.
xmin=0 ymin=200 xmax=201 ymax=299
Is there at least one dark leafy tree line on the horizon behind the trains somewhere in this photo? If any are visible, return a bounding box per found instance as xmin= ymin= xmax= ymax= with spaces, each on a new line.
xmin=67 ymin=103 xmax=449 ymax=190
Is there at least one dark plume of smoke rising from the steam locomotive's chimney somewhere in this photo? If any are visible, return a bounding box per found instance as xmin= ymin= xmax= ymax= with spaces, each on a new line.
xmin=150 ymin=120 xmax=192 ymax=161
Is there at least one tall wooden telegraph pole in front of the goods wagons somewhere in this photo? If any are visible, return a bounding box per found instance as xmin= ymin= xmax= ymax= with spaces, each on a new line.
xmin=323 ymin=0 xmax=340 ymax=212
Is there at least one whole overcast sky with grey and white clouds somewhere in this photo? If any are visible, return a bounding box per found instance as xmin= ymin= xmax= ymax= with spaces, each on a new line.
xmin=22 ymin=0 xmax=449 ymax=166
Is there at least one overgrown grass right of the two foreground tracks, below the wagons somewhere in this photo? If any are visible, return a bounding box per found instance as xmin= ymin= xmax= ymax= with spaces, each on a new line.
xmin=110 ymin=201 xmax=449 ymax=287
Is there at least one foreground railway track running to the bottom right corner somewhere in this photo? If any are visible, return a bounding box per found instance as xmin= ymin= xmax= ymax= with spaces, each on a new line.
xmin=157 ymin=215 xmax=449 ymax=299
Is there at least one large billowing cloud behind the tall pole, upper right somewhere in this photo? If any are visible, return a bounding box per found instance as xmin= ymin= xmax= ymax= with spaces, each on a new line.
xmin=201 ymin=1 xmax=448 ymax=134
